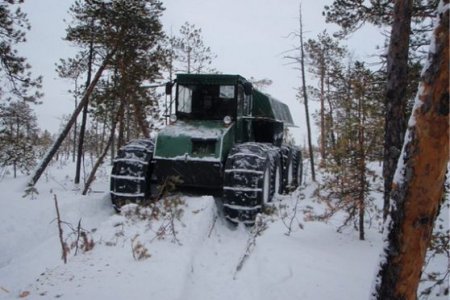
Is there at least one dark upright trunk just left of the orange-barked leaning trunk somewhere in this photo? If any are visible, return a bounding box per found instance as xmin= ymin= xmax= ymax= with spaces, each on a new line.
xmin=383 ymin=0 xmax=412 ymax=219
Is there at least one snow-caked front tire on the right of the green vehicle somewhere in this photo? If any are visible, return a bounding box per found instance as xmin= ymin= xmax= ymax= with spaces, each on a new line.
xmin=223 ymin=143 xmax=281 ymax=225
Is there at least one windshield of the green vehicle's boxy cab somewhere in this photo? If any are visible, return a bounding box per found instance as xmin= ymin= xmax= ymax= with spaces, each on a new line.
xmin=177 ymin=84 xmax=236 ymax=120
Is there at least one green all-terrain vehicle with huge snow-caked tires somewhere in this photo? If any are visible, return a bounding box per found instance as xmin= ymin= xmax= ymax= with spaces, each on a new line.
xmin=111 ymin=74 xmax=302 ymax=224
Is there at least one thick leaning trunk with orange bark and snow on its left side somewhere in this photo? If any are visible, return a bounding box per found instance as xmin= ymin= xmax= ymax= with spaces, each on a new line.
xmin=372 ymin=0 xmax=449 ymax=300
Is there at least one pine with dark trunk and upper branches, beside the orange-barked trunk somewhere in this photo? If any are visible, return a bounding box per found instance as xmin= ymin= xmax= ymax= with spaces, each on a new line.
xmin=324 ymin=0 xmax=438 ymax=217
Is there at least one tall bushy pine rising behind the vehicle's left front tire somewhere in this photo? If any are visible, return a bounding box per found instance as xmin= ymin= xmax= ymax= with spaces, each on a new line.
xmin=63 ymin=0 xmax=166 ymax=146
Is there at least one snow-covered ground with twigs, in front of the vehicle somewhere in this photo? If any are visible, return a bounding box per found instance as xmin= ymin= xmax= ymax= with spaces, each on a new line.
xmin=0 ymin=162 xmax=448 ymax=300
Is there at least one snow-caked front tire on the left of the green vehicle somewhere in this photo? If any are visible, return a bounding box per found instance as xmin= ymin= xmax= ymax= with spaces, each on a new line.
xmin=111 ymin=139 xmax=154 ymax=211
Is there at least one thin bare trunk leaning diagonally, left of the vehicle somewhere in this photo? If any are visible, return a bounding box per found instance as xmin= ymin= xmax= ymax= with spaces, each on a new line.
xmin=28 ymin=51 xmax=115 ymax=186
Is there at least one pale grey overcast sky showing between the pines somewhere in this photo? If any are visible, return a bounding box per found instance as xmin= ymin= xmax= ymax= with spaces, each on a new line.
xmin=20 ymin=0 xmax=382 ymax=144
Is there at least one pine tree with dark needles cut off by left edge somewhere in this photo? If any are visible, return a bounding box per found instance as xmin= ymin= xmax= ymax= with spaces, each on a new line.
xmin=0 ymin=0 xmax=42 ymax=177
